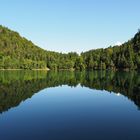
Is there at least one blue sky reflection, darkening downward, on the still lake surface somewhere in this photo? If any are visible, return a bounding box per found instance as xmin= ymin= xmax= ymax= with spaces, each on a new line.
xmin=0 ymin=85 xmax=140 ymax=140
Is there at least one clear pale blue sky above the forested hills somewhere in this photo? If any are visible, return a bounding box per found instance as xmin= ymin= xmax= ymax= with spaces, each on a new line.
xmin=0 ymin=0 xmax=140 ymax=52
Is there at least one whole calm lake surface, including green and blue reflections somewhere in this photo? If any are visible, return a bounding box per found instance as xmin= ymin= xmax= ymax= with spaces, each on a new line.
xmin=0 ymin=71 xmax=140 ymax=140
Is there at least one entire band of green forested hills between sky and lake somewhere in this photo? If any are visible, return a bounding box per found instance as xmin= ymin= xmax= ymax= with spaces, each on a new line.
xmin=0 ymin=26 xmax=140 ymax=70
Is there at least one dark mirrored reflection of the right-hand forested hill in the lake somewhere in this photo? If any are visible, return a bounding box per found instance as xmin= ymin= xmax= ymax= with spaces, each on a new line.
xmin=82 ymin=71 xmax=140 ymax=107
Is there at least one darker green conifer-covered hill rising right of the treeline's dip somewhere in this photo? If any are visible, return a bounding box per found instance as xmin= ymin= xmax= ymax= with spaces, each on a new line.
xmin=81 ymin=32 xmax=140 ymax=69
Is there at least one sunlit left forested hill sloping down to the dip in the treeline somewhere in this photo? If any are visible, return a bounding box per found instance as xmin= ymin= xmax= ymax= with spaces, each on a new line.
xmin=0 ymin=26 xmax=78 ymax=69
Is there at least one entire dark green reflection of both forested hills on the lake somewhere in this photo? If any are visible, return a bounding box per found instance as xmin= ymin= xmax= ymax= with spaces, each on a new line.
xmin=0 ymin=71 xmax=140 ymax=112
